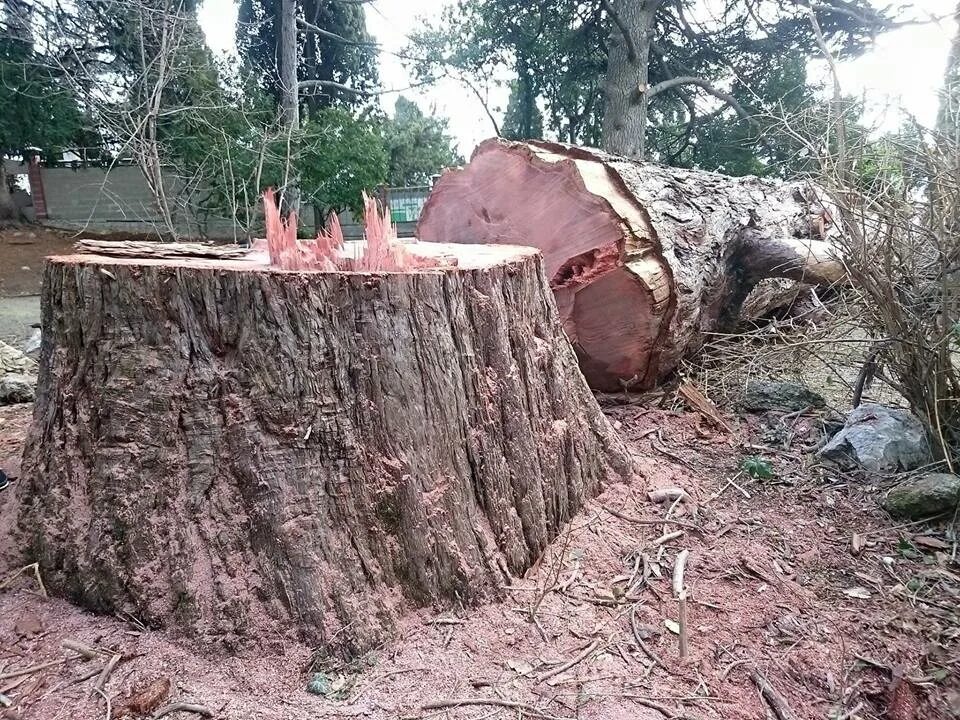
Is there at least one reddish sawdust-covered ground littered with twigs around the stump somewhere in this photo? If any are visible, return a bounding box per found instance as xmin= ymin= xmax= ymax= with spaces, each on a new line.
xmin=0 ymin=405 xmax=960 ymax=720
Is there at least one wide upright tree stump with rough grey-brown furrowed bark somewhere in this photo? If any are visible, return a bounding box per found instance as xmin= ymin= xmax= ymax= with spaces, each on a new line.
xmin=19 ymin=243 xmax=634 ymax=654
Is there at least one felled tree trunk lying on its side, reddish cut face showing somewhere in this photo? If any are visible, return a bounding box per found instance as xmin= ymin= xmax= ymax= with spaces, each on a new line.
xmin=417 ymin=140 xmax=845 ymax=391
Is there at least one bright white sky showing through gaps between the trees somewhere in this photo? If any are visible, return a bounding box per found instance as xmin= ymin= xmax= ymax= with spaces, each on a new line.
xmin=199 ymin=0 xmax=956 ymax=157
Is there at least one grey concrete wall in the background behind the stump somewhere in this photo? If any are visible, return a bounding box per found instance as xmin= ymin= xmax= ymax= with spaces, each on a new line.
xmin=31 ymin=165 xmax=429 ymax=240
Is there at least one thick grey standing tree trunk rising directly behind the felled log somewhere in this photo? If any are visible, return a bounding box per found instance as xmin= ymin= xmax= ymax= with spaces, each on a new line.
xmin=603 ymin=0 xmax=662 ymax=160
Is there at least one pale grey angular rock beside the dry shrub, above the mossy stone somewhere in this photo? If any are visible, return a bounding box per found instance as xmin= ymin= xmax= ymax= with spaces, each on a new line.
xmin=819 ymin=403 xmax=933 ymax=473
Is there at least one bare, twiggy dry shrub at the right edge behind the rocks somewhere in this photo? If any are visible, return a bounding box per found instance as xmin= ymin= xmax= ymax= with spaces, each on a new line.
xmin=791 ymin=114 xmax=960 ymax=462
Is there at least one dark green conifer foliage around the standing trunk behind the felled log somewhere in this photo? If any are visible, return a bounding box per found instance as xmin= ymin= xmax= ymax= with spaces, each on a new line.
xmin=411 ymin=0 xmax=887 ymax=164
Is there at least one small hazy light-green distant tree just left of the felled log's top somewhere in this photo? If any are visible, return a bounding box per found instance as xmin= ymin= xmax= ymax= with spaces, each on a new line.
xmin=382 ymin=97 xmax=463 ymax=187
